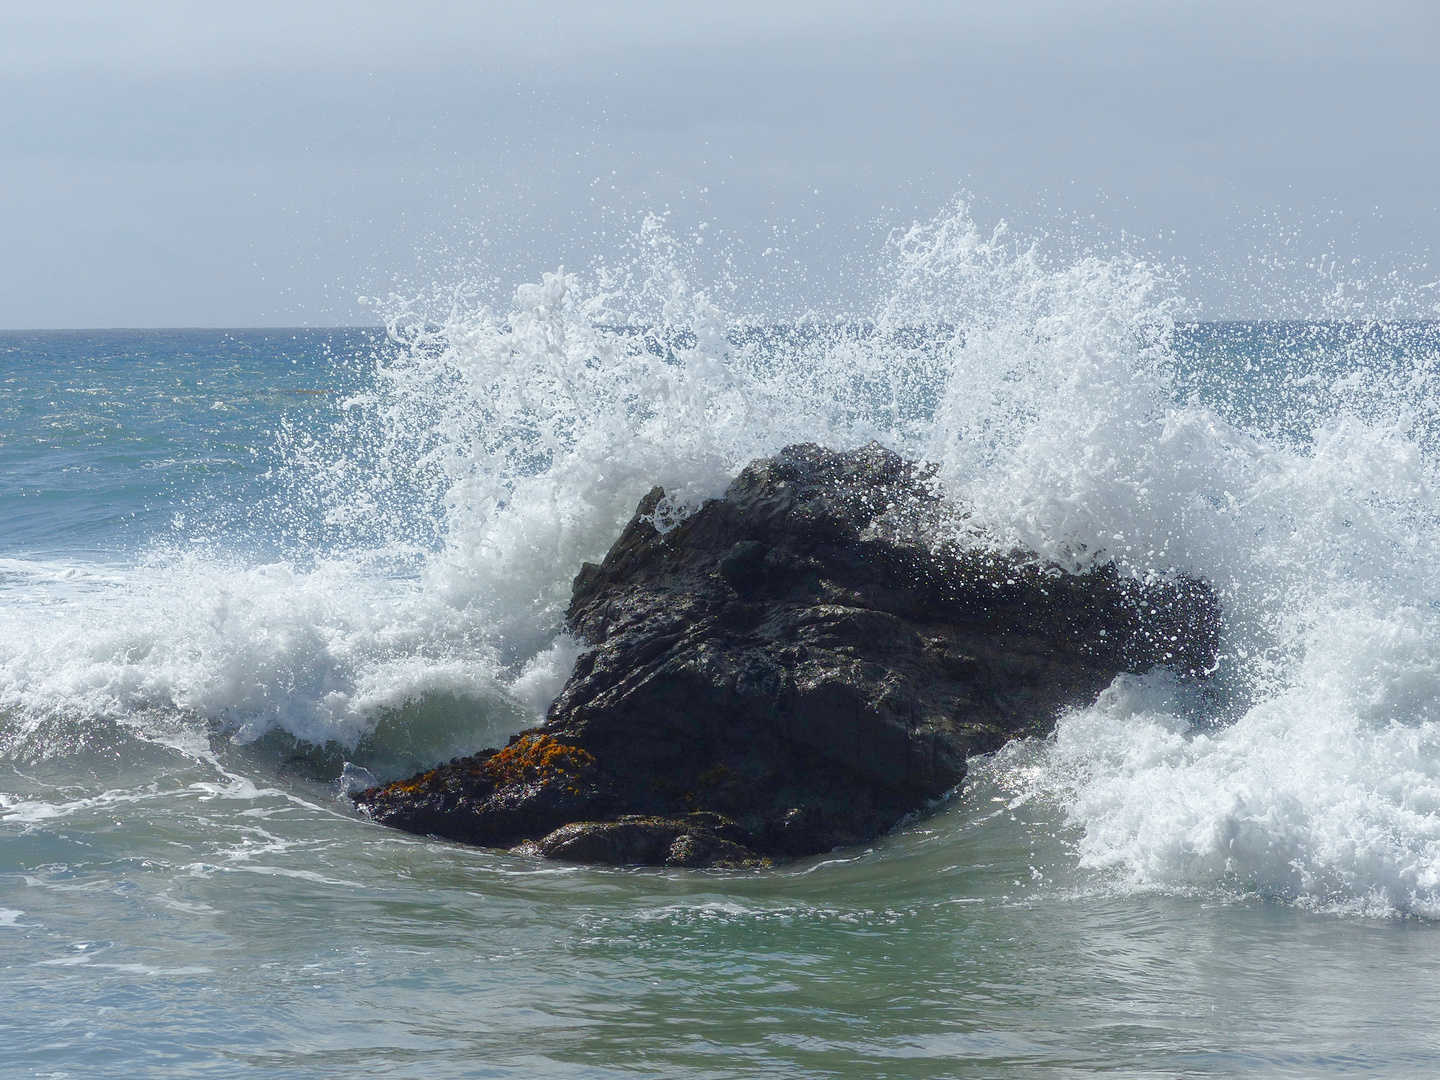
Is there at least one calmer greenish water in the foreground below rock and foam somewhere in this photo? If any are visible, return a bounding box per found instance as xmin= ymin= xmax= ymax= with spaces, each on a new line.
xmin=0 ymin=724 xmax=1440 ymax=1079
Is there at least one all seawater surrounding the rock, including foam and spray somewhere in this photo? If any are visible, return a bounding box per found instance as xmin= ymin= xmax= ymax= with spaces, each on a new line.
xmin=0 ymin=213 xmax=1440 ymax=1077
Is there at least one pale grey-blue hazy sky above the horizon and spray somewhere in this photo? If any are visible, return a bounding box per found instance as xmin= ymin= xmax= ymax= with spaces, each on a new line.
xmin=0 ymin=0 xmax=1440 ymax=328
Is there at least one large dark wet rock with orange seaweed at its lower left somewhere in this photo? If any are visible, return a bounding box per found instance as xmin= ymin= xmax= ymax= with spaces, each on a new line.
xmin=356 ymin=445 xmax=1220 ymax=865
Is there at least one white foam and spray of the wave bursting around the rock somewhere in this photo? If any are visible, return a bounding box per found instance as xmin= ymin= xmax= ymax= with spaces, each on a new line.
xmin=0 ymin=201 xmax=1440 ymax=916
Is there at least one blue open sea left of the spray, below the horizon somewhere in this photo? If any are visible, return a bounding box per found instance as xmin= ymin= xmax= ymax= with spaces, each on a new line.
xmin=0 ymin=330 xmax=384 ymax=557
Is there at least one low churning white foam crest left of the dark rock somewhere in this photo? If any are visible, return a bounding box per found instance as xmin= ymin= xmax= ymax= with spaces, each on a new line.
xmin=0 ymin=556 xmax=517 ymax=744
